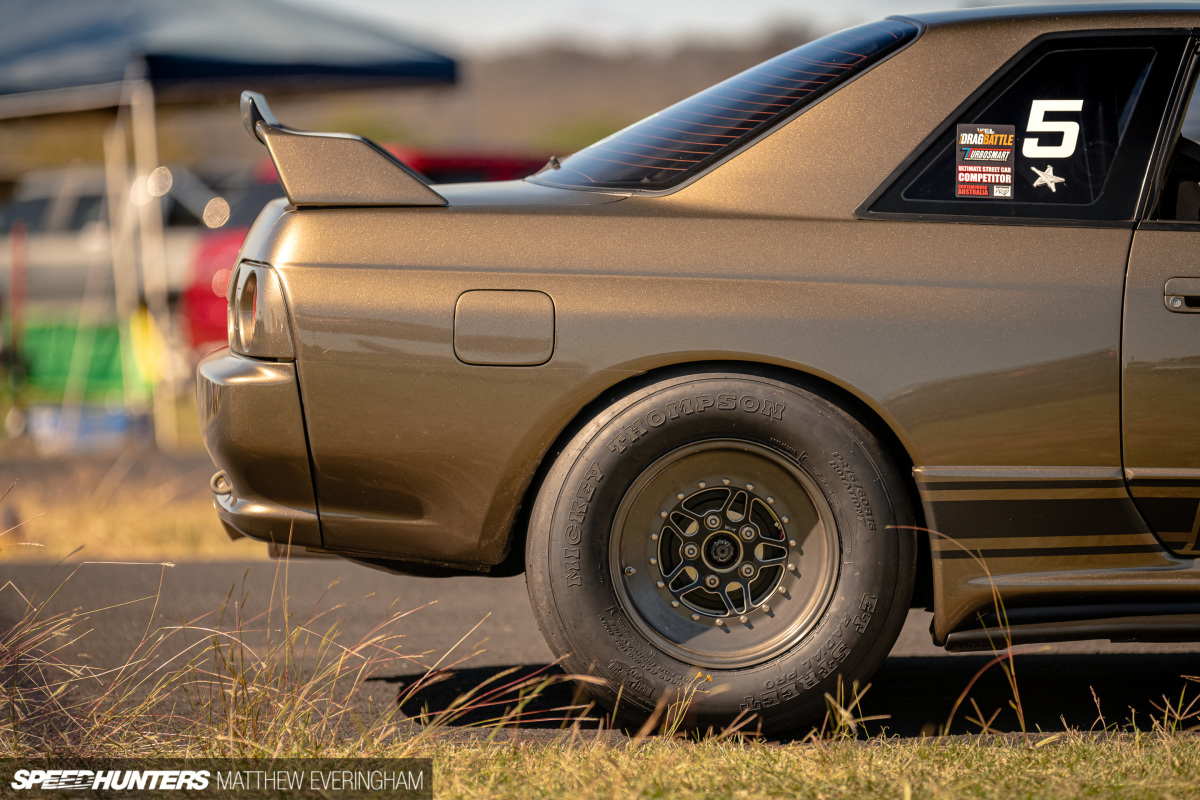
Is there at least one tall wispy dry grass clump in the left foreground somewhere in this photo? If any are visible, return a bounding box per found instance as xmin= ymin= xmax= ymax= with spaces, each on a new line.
xmin=0 ymin=547 xmax=592 ymax=758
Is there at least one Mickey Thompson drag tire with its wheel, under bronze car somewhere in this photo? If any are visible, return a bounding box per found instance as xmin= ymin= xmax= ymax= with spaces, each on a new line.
xmin=526 ymin=372 xmax=917 ymax=732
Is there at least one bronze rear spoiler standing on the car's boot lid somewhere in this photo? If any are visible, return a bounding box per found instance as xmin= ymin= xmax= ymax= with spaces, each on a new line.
xmin=241 ymin=91 xmax=446 ymax=206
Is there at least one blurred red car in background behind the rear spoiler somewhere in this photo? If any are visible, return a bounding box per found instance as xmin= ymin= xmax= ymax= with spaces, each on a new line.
xmin=182 ymin=146 xmax=546 ymax=349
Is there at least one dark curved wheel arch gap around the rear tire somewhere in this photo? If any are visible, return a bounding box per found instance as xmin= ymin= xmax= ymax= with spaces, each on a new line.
xmin=493 ymin=359 xmax=934 ymax=608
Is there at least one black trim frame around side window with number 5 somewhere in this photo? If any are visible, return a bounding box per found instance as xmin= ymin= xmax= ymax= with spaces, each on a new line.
xmin=854 ymin=28 xmax=1196 ymax=229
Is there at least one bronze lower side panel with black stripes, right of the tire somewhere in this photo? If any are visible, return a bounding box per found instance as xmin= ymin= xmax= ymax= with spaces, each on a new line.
xmin=913 ymin=467 xmax=1185 ymax=644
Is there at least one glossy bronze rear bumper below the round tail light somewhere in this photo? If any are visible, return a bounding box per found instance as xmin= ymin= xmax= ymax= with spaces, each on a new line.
xmin=196 ymin=349 xmax=320 ymax=547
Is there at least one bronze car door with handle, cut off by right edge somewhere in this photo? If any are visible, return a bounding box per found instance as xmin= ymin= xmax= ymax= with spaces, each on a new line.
xmin=1121 ymin=43 xmax=1200 ymax=555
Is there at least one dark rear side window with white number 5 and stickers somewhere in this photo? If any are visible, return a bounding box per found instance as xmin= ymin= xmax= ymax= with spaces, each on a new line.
xmin=870 ymin=35 xmax=1186 ymax=221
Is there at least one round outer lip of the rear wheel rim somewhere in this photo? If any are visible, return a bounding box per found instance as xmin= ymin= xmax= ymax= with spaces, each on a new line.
xmin=608 ymin=437 xmax=842 ymax=669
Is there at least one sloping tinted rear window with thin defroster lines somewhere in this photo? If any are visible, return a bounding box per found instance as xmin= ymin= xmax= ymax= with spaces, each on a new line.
xmin=534 ymin=19 xmax=918 ymax=191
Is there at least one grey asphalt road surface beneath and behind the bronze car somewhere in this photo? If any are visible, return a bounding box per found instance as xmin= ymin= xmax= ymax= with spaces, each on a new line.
xmin=0 ymin=559 xmax=1200 ymax=736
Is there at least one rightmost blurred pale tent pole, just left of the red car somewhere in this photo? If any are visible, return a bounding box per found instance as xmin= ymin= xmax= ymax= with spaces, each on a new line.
xmin=130 ymin=77 xmax=179 ymax=450
